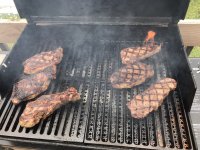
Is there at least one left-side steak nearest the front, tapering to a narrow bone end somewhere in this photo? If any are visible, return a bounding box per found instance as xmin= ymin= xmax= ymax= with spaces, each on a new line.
xmin=19 ymin=87 xmax=80 ymax=128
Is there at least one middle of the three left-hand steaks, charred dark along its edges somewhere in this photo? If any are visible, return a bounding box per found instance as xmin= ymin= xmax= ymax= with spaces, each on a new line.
xmin=10 ymin=65 xmax=56 ymax=104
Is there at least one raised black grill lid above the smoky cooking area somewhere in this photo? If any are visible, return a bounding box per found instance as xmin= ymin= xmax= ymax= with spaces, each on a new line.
xmin=14 ymin=0 xmax=189 ymax=22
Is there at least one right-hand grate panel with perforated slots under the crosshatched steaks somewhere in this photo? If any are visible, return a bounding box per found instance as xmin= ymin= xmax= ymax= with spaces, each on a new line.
xmin=85 ymin=41 xmax=192 ymax=149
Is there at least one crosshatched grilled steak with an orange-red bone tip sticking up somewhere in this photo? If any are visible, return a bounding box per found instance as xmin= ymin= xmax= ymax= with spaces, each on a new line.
xmin=120 ymin=31 xmax=161 ymax=64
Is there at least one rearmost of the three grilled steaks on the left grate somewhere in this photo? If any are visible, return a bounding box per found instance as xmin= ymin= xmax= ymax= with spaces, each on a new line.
xmin=23 ymin=47 xmax=63 ymax=74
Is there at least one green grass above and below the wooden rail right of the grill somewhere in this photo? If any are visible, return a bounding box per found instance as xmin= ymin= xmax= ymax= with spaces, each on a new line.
xmin=186 ymin=0 xmax=200 ymax=57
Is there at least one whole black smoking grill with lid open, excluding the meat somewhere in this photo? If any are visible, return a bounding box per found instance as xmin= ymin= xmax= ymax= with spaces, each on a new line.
xmin=0 ymin=0 xmax=197 ymax=149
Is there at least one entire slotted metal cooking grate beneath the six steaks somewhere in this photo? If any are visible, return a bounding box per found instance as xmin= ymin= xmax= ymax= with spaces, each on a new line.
xmin=0 ymin=40 xmax=192 ymax=149
